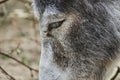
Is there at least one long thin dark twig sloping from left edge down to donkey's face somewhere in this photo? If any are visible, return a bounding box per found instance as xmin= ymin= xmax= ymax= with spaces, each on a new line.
xmin=0 ymin=52 xmax=38 ymax=73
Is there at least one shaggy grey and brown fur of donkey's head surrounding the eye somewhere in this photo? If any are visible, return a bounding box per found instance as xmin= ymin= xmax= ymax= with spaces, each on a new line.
xmin=33 ymin=0 xmax=120 ymax=80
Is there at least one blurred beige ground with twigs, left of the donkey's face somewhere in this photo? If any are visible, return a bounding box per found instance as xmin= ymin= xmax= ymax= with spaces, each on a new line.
xmin=0 ymin=0 xmax=40 ymax=80
